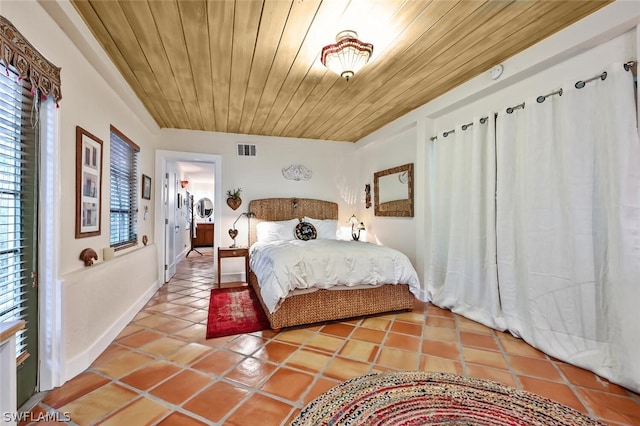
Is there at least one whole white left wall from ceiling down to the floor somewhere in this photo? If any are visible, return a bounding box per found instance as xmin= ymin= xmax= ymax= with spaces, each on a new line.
xmin=0 ymin=0 xmax=159 ymax=389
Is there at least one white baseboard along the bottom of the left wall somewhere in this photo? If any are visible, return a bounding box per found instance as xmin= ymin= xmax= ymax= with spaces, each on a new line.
xmin=63 ymin=280 xmax=159 ymax=382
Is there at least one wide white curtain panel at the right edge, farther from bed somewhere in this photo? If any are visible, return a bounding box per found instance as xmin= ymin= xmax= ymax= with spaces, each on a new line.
xmin=496 ymin=64 xmax=640 ymax=391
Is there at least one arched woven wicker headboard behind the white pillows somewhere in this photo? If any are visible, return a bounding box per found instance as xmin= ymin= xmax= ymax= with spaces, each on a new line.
xmin=249 ymin=198 xmax=338 ymax=245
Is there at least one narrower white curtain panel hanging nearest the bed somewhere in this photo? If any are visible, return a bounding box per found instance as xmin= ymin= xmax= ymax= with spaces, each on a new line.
xmin=427 ymin=118 xmax=505 ymax=330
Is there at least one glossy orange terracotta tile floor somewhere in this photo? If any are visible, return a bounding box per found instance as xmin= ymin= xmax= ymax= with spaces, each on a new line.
xmin=25 ymin=250 xmax=640 ymax=425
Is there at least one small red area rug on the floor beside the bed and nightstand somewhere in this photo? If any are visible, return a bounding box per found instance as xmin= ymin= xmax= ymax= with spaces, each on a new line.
xmin=207 ymin=287 xmax=269 ymax=339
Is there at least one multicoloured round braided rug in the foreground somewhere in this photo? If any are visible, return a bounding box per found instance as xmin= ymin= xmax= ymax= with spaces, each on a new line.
xmin=291 ymin=372 xmax=602 ymax=426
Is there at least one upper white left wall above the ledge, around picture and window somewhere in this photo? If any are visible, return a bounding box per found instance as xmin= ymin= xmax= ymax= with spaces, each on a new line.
xmin=0 ymin=0 xmax=159 ymax=274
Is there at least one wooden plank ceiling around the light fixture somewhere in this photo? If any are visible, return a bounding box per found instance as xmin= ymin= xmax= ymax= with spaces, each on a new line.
xmin=72 ymin=0 xmax=610 ymax=142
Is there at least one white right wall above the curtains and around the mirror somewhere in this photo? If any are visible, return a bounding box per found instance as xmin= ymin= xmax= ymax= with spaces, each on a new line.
xmin=356 ymin=0 xmax=640 ymax=296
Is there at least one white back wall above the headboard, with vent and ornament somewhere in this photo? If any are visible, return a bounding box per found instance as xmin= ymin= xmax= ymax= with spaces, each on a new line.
xmin=158 ymin=129 xmax=366 ymax=276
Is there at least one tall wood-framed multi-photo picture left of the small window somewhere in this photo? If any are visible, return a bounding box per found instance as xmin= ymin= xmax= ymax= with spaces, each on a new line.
xmin=76 ymin=126 xmax=102 ymax=238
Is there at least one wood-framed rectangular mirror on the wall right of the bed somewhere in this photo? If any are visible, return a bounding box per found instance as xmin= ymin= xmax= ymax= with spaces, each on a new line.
xmin=373 ymin=163 xmax=413 ymax=217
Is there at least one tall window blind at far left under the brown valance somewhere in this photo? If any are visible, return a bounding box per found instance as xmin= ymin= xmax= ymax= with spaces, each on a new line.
xmin=0 ymin=67 xmax=37 ymax=362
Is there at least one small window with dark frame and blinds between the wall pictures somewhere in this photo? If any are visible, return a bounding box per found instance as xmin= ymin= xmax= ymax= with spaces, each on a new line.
xmin=109 ymin=126 xmax=140 ymax=250
